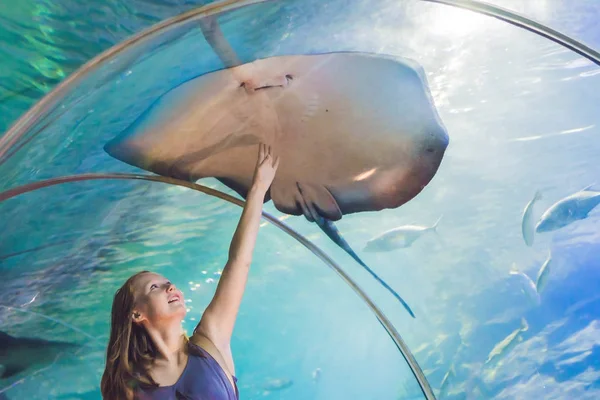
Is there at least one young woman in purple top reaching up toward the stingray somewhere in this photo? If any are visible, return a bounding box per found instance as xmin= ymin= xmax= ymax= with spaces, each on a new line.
xmin=101 ymin=144 xmax=279 ymax=400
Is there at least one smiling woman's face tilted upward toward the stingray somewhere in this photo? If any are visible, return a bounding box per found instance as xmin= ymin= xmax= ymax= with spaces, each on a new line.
xmin=133 ymin=272 xmax=186 ymax=323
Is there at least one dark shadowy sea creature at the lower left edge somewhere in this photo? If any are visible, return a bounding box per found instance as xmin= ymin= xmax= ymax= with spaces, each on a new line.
xmin=0 ymin=331 xmax=80 ymax=380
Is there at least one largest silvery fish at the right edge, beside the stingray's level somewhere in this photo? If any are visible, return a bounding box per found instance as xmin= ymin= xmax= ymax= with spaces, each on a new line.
xmin=535 ymin=185 xmax=600 ymax=233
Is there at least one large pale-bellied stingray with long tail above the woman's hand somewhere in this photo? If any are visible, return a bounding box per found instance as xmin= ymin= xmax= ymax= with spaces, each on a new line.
xmin=104 ymin=20 xmax=448 ymax=317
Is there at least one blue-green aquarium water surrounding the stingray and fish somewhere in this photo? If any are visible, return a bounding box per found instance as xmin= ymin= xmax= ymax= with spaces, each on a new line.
xmin=0 ymin=0 xmax=600 ymax=399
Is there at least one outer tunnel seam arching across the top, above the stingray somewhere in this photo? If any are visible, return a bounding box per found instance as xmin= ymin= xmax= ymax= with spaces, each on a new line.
xmin=0 ymin=0 xmax=600 ymax=166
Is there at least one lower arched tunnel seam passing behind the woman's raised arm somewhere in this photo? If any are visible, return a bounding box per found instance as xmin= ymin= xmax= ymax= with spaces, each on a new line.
xmin=0 ymin=173 xmax=436 ymax=400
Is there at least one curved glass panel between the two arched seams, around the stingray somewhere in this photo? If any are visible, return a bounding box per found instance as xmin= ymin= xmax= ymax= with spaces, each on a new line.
xmin=0 ymin=1 xmax=600 ymax=399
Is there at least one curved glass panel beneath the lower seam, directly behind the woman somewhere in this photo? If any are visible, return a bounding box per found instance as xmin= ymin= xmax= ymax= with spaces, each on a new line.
xmin=0 ymin=181 xmax=422 ymax=399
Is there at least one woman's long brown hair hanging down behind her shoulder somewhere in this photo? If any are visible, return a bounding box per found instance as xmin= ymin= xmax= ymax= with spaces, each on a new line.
xmin=100 ymin=271 xmax=158 ymax=400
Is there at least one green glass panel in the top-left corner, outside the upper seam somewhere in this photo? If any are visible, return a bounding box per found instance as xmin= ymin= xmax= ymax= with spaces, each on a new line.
xmin=0 ymin=0 xmax=205 ymax=132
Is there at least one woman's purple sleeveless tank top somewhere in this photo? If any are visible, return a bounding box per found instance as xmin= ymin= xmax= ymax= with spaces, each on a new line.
xmin=135 ymin=343 xmax=239 ymax=400
